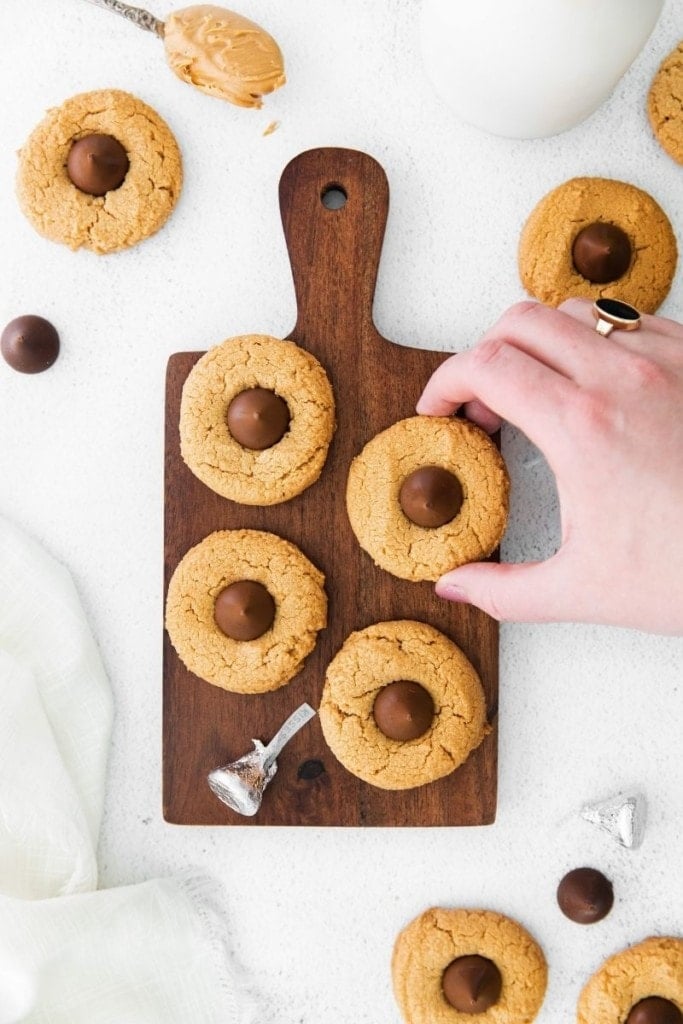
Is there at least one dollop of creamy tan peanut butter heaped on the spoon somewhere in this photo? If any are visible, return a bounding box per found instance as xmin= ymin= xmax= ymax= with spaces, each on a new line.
xmin=164 ymin=4 xmax=287 ymax=106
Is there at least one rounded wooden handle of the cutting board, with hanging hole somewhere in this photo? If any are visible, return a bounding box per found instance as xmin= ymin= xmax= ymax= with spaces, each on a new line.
xmin=280 ymin=147 xmax=389 ymax=341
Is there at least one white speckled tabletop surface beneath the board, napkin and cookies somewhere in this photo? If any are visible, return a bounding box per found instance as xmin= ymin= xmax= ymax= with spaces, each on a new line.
xmin=0 ymin=0 xmax=683 ymax=1024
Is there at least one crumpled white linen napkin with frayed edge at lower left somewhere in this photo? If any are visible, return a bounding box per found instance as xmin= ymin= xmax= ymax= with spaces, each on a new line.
xmin=0 ymin=517 xmax=256 ymax=1024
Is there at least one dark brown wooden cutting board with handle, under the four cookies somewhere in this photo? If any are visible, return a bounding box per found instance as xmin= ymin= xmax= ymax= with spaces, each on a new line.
xmin=163 ymin=148 xmax=498 ymax=825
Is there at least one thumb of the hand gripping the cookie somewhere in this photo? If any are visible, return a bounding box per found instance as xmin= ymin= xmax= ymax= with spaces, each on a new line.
xmin=435 ymin=552 xmax=575 ymax=623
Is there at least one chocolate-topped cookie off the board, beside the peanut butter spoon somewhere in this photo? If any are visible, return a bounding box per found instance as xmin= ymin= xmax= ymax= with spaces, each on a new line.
xmin=16 ymin=89 xmax=182 ymax=253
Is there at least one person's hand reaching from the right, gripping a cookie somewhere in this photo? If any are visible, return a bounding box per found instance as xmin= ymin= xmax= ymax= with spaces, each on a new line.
xmin=417 ymin=299 xmax=683 ymax=634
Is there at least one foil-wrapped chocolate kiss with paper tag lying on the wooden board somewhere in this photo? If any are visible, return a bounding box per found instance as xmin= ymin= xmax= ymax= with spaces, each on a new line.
xmin=208 ymin=703 xmax=315 ymax=817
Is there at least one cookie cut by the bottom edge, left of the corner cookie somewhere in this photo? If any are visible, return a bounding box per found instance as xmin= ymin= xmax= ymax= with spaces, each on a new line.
xmin=391 ymin=907 xmax=548 ymax=1024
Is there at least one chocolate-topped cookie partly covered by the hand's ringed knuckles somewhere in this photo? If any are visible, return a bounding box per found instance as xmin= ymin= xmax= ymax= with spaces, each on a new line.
xmin=519 ymin=178 xmax=678 ymax=313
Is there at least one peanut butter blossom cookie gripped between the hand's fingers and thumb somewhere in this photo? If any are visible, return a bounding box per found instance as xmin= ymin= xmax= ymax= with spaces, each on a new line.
xmin=346 ymin=416 xmax=510 ymax=581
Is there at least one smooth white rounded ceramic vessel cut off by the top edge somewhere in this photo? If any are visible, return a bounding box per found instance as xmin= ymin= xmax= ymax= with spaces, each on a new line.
xmin=421 ymin=0 xmax=664 ymax=138
